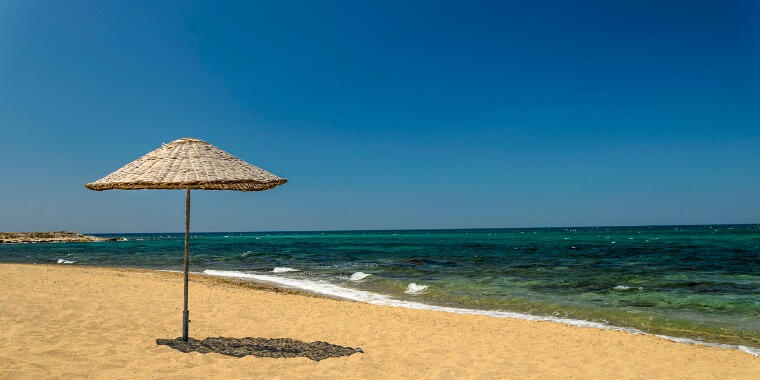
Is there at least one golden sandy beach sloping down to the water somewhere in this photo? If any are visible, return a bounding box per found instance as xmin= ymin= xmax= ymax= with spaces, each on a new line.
xmin=0 ymin=264 xmax=760 ymax=379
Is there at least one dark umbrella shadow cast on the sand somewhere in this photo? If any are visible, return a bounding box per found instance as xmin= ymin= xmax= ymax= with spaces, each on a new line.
xmin=156 ymin=337 xmax=363 ymax=361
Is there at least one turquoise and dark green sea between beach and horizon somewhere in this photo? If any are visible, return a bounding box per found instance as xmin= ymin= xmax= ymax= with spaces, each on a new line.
xmin=0 ymin=225 xmax=760 ymax=347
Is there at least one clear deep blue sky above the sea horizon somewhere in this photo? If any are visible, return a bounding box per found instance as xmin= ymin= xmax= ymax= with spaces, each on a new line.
xmin=0 ymin=0 xmax=760 ymax=232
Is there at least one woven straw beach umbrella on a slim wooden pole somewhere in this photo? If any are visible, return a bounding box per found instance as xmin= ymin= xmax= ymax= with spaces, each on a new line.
xmin=85 ymin=138 xmax=288 ymax=341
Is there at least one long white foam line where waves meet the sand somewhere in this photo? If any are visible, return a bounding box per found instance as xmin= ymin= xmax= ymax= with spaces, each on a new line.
xmin=202 ymin=269 xmax=760 ymax=356
